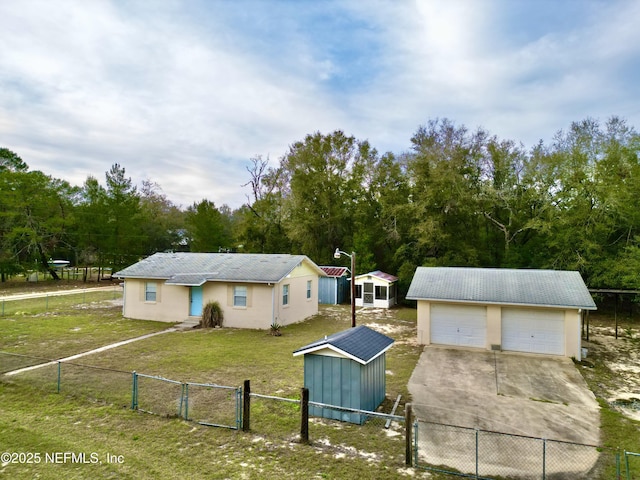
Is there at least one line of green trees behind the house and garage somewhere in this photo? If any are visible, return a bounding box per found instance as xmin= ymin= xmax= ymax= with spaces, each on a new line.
xmin=0 ymin=117 xmax=640 ymax=291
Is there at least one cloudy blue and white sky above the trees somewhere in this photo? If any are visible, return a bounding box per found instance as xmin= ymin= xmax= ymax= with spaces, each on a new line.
xmin=0 ymin=0 xmax=640 ymax=208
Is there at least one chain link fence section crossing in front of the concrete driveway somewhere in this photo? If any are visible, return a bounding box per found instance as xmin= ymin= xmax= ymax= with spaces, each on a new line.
xmin=414 ymin=420 xmax=619 ymax=480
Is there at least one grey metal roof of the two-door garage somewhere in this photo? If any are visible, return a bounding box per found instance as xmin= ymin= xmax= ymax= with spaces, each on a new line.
xmin=407 ymin=267 xmax=596 ymax=310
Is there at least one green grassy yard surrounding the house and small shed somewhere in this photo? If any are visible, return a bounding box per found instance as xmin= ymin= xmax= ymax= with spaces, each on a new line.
xmin=0 ymin=286 xmax=640 ymax=479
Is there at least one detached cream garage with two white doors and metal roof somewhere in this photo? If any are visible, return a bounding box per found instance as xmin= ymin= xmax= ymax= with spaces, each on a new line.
xmin=407 ymin=267 xmax=596 ymax=360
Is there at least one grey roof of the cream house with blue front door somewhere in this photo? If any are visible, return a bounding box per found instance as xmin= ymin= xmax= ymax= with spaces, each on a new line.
xmin=115 ymin=252 xmax=325 ymax=286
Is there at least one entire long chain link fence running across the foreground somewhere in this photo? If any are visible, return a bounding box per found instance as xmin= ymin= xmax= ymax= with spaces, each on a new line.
xmin=5 ymin=352 xmax=640 ymax=480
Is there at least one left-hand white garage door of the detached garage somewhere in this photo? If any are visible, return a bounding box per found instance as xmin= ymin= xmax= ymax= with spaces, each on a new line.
xmin=431 ymin=304 xmax=487 ymax=348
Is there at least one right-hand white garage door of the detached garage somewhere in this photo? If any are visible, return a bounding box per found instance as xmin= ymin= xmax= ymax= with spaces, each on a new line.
xmin=502 ymin=308 xmax=564 ymax=355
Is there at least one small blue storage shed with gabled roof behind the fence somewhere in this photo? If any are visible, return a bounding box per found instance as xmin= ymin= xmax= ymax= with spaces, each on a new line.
xmin=293 ymin=325 xmax=394 ymax=425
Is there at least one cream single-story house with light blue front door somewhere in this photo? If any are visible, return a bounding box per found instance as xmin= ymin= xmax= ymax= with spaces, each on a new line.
xmin=114 ymin=252 xmax=325 ymax=329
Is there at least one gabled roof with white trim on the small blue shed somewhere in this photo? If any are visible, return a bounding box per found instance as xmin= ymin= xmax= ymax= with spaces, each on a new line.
xmin=293 ymin=325 xmax=394 ymax=365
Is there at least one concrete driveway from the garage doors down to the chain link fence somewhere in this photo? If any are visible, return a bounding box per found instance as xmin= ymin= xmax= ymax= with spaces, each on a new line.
xmin=409 ymin=346 xmax=600 ymax=445
